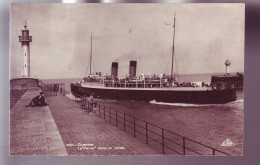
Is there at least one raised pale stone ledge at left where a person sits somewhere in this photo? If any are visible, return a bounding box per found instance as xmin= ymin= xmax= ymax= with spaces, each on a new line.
xmin=10 ymin=90 xmax=68 ymax=155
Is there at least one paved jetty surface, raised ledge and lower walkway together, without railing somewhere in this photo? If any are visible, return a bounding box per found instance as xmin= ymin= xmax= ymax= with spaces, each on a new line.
xmin=10 ymin=88 xmax=158 ymax=156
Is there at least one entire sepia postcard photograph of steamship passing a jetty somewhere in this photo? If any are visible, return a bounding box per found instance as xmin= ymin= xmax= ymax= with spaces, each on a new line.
xmin=9 ymin=3 xmax=245 ymax=156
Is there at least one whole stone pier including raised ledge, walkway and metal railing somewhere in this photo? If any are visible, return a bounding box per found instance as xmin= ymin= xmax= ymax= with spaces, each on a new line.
xmin=10 ymin=84 xmax=235 ymax=156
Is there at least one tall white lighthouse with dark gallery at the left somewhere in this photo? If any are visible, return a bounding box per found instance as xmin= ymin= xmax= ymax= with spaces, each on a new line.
xmin=19 ymin=21 xmax=32 ymax=77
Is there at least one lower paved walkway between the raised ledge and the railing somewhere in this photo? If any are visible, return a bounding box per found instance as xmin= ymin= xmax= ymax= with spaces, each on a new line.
xmin=46 ymin=95 xmax=161 ymax=155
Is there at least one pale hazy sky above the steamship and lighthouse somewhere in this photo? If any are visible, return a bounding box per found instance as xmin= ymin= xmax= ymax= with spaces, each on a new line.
xmin=10 ymin=3 xmax=245 ymax=79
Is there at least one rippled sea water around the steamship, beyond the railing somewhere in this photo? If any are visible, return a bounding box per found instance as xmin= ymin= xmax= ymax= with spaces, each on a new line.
xmin=40 ymin=75 xmax=244 ymax=155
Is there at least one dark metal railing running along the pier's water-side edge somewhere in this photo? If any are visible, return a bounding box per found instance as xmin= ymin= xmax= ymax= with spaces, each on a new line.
xmin=71 ymin=95 xmax=230 ymax=156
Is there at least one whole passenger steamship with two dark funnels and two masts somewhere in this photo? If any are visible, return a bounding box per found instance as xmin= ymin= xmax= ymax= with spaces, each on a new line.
xmin=70 ymin=16 xmax=236 ymax=104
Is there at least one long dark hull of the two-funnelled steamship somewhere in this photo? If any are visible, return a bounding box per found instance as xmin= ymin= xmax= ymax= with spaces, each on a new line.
xmin=71 ymin=84 xmax=236 ymax=104
